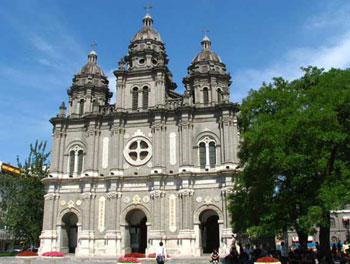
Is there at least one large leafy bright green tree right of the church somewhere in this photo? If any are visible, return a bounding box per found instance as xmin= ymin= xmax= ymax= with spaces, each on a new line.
xmin=230 ymin=67 xmax=350 ymax=254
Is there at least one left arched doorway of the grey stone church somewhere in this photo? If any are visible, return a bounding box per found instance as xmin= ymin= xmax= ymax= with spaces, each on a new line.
xmin=61 ymin=212 xmax=78 ymax=253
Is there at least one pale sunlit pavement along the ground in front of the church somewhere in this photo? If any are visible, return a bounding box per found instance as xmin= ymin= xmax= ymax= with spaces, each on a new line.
xmin=0 ymin=256 xmax=210 ymax=264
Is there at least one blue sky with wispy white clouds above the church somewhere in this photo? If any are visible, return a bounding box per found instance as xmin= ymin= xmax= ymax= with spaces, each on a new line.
xmin=0 ymin=0 xmax=350 ymax=164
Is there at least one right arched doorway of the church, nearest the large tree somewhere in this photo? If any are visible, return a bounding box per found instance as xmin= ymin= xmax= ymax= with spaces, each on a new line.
xmin=199 ymin=210 xmax=220 ymax=253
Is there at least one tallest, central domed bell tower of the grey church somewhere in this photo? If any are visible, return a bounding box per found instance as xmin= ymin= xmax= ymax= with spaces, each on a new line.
xmin=114 ymin=13 xmax=176 ymax=112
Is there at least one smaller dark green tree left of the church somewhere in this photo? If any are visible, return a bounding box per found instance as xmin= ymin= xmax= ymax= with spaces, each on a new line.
xmin=0 ymin=141 xmax=49 ymax=246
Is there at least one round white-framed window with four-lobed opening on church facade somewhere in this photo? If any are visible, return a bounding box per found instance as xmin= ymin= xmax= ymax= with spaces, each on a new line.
xmin=124 ymin=137 xmax=152 ymax=166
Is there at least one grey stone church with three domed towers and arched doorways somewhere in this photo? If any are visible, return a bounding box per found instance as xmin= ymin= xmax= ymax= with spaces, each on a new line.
xmin=39 ymin=13 xmax=239 ymax=257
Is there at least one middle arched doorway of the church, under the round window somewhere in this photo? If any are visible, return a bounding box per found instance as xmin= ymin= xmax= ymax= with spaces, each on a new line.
xmin=125 ymin=209 xmax=147 ymax=253
